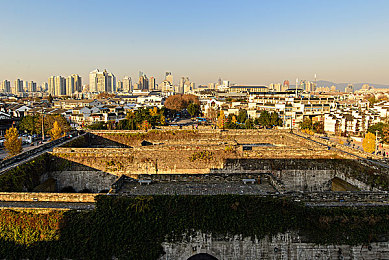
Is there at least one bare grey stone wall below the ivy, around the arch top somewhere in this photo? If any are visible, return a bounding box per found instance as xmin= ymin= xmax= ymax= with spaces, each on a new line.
xmin=159 ymin=232 xmax=389 ymax=260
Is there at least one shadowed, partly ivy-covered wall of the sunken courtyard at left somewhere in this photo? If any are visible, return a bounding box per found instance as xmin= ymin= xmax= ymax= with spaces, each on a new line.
xmin=0 ymin=153 xmax=118 ymax=192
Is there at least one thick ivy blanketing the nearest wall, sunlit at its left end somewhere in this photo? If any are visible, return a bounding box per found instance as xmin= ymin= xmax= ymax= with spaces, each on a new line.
xmin=0 ymin=195 xmax=389 ymax=259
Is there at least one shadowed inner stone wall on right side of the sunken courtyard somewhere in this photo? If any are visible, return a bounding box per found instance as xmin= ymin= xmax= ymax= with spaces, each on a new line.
xmin=211 ymin=159 xmax=389 ymax=191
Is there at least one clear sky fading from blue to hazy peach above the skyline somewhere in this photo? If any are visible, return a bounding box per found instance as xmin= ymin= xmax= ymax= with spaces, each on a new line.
xmin=0 ymin=0 xmax=389 ymax=84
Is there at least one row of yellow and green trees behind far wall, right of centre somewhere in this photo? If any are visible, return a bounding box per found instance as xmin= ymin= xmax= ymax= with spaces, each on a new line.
xmin=217 ymin=109 xmax=282 ymax=129
